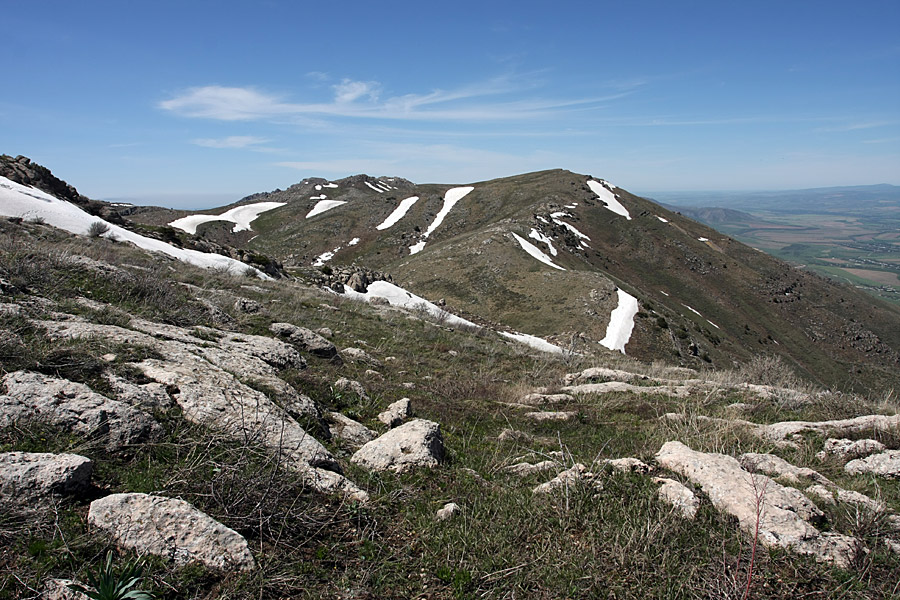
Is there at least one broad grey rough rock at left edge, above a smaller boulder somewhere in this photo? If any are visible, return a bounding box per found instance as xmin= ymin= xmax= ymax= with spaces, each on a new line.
xmin=0 ymin=371 xmax=162 ymax=450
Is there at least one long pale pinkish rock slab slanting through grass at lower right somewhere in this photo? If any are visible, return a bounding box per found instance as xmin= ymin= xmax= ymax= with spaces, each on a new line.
xmin=656 ymin=441 xmax=856 ymax=567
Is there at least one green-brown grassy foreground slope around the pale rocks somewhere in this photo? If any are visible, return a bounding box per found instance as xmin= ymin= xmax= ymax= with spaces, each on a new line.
xmin=0 ymin=224 xmax=900 ymax=599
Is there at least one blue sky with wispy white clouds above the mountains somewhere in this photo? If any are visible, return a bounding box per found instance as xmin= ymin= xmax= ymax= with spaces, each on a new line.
xmin=0 ymin=0 xmax=900 ymax=206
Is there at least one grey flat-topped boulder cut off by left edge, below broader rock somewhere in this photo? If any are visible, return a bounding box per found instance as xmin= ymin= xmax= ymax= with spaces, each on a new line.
xmin=0 ymin=452 xmax=94 ymax=504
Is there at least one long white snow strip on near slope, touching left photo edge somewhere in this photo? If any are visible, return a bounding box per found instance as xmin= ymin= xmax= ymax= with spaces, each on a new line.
xmin=0 ymin=177 xmax=269 ymax=279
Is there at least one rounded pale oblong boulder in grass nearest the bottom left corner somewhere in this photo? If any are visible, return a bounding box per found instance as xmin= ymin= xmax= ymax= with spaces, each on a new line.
xmin=88 ymin=494 xmax=256 ymax=571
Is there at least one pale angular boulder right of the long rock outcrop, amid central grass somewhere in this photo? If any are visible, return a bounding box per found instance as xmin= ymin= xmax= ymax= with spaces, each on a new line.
xmin=350 ymin=419 xmax=445 ymax=473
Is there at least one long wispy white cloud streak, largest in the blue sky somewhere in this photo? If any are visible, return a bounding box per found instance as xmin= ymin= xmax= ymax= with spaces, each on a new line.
xmin=159 ymin=78 xmax=631 ymax=121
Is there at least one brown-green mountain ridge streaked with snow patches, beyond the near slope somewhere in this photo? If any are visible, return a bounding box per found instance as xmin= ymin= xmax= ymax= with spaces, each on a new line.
xmin=128 ymin=170 xmax=900 ymax=388
